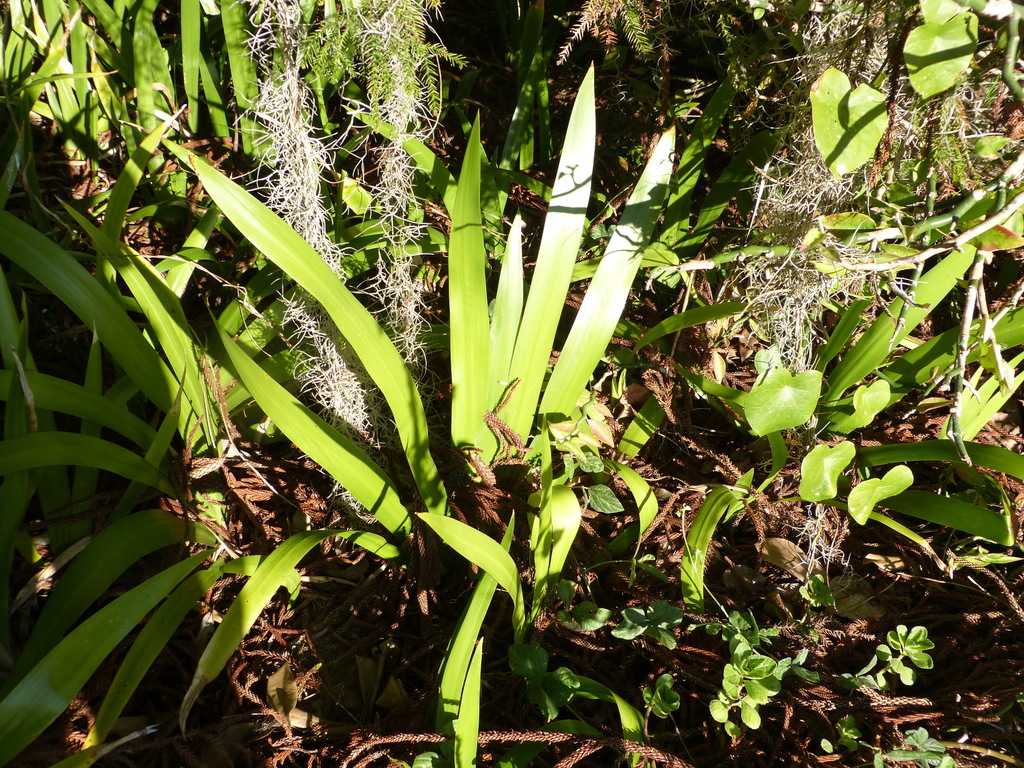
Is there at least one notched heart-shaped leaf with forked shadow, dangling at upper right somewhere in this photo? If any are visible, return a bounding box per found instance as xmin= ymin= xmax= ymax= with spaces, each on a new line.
xmin=811 ymin=69 xmax=889 ymax=178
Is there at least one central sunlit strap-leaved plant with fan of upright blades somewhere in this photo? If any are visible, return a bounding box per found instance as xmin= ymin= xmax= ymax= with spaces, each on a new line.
xmin=182 ymin=72 xmax=675 ymax=765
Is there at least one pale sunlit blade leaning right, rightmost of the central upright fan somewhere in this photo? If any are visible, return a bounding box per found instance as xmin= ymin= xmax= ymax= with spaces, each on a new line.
xmin=541 ymin=129 xmax=676 ymax=414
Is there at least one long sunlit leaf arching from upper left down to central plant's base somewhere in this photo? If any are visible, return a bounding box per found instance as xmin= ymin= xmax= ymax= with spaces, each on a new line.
xmin=191 ymin=148 xmax=446 ymax=514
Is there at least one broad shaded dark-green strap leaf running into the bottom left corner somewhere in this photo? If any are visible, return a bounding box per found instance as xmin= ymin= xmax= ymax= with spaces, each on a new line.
xmin=0 ymin=551 xmax=210 ymax=766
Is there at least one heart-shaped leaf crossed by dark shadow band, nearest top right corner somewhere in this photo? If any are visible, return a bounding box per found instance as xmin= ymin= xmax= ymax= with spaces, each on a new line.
xmin=903 ymin=13 xmax=978 ymax=98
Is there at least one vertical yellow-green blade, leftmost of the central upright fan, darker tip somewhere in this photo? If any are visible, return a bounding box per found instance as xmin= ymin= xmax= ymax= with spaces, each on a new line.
xmin=449 ymin=118 xmax=490 ymax=450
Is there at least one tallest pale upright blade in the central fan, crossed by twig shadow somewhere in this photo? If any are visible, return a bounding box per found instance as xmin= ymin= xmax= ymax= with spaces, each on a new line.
xmin=502 ymin=68 xmax=597 ymax=437
